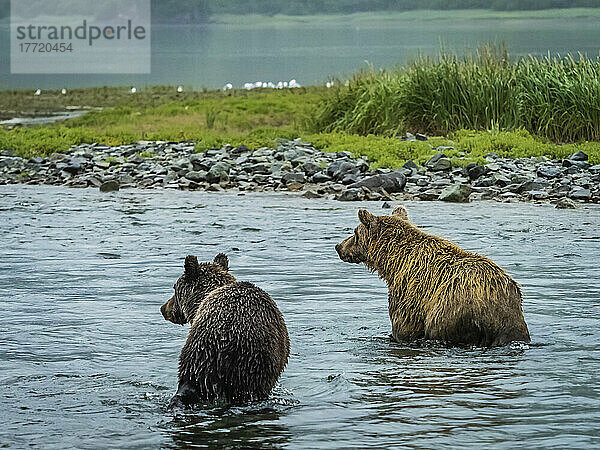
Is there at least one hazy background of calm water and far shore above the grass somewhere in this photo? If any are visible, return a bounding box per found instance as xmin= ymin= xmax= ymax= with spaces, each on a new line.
xmin=0 ymin=0 xmax=600 ymax=90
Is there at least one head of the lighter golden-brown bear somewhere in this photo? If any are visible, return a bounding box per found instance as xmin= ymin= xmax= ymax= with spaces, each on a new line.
xmin=335 ymin=206 xmax=408 ymax=266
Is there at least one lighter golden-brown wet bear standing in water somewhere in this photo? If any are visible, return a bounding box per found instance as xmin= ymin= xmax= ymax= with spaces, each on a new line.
xmin=336 ymin=207 xmax=530 ymax=346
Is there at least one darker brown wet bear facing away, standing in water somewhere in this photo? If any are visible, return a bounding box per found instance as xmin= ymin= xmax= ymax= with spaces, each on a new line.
xmin=160 ymin=253 xmax=290 ymax=406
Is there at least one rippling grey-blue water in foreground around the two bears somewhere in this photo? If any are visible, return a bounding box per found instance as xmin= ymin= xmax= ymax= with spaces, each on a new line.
xmin=0 ymin=186 xmax=600 ymax=448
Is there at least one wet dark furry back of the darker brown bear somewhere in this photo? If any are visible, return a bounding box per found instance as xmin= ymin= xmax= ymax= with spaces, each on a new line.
xmin=180 ymin=282 xmax=289 ymax=402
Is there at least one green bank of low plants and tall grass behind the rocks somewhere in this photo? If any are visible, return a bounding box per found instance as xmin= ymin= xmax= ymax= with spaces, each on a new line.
xmin=0 ymin=48 xmax=600 ymax=167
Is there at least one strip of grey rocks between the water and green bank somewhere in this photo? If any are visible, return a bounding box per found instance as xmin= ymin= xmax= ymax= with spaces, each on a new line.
xmin=0 ymin=141 xmax=600 ymax=208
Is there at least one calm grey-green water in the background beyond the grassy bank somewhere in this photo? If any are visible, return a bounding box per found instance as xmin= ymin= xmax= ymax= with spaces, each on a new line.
xmin=0 ymin=13 xmax=600 ymax=89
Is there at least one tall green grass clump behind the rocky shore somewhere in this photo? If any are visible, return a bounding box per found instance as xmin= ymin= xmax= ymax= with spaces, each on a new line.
xmin=312 ymin=46 xmax=600 ymax=142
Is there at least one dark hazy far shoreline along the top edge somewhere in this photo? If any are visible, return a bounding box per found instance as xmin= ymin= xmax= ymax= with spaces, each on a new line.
xmin=0 ymin=0 xmax=600 ymax=23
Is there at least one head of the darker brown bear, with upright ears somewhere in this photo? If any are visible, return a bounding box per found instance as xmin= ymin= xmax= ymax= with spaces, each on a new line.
xmin=160 ymin=253 xmax=235 ymax=325
